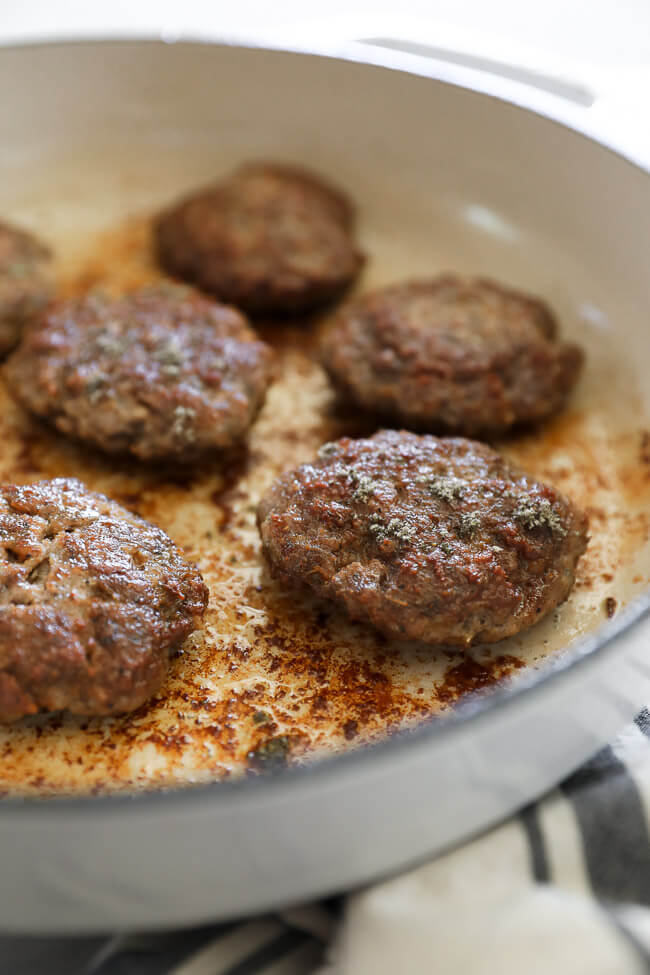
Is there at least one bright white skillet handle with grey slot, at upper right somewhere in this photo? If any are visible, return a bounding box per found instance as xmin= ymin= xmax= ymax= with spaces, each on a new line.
xmin=265 ymin=11 xmax=650 ymax=168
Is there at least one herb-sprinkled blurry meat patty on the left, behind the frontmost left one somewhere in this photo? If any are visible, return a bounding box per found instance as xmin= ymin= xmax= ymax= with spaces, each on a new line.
xmin=7 ymin=285 xmax=271 ymax=460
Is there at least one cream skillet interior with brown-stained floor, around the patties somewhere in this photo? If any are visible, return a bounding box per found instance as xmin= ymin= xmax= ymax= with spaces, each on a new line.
xmin=0 ymin=45 xmax=650 ymax=796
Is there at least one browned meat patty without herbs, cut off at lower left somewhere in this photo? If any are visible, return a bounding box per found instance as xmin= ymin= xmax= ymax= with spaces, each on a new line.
xmin=0 ymin=479 xmax=208 ymax=722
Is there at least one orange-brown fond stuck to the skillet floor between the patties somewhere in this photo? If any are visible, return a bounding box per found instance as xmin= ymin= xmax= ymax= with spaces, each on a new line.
xmin=0 ymin=219 xmax=650 ymax=795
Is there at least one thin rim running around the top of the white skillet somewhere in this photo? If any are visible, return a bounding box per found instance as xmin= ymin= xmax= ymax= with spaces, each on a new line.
xmin=0 ymin=32 xmax=650 ymax=820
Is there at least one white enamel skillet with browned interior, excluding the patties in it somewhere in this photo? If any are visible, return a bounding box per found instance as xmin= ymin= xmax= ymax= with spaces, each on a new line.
xmin=0 ymin=41 xmax=650 ymax=932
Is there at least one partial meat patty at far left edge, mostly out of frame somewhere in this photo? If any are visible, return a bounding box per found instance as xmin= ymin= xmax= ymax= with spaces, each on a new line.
xmin=0 ymin=222 xmax=52 ymax=357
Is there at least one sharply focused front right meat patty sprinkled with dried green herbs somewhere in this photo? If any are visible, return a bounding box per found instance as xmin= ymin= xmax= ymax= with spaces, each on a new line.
xmin=258 ymin=430 xmax=587 ymax=647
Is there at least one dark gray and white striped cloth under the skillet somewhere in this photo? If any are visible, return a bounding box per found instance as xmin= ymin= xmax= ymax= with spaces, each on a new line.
xmin=6 ymin=709 xmax=650 ymax=975
